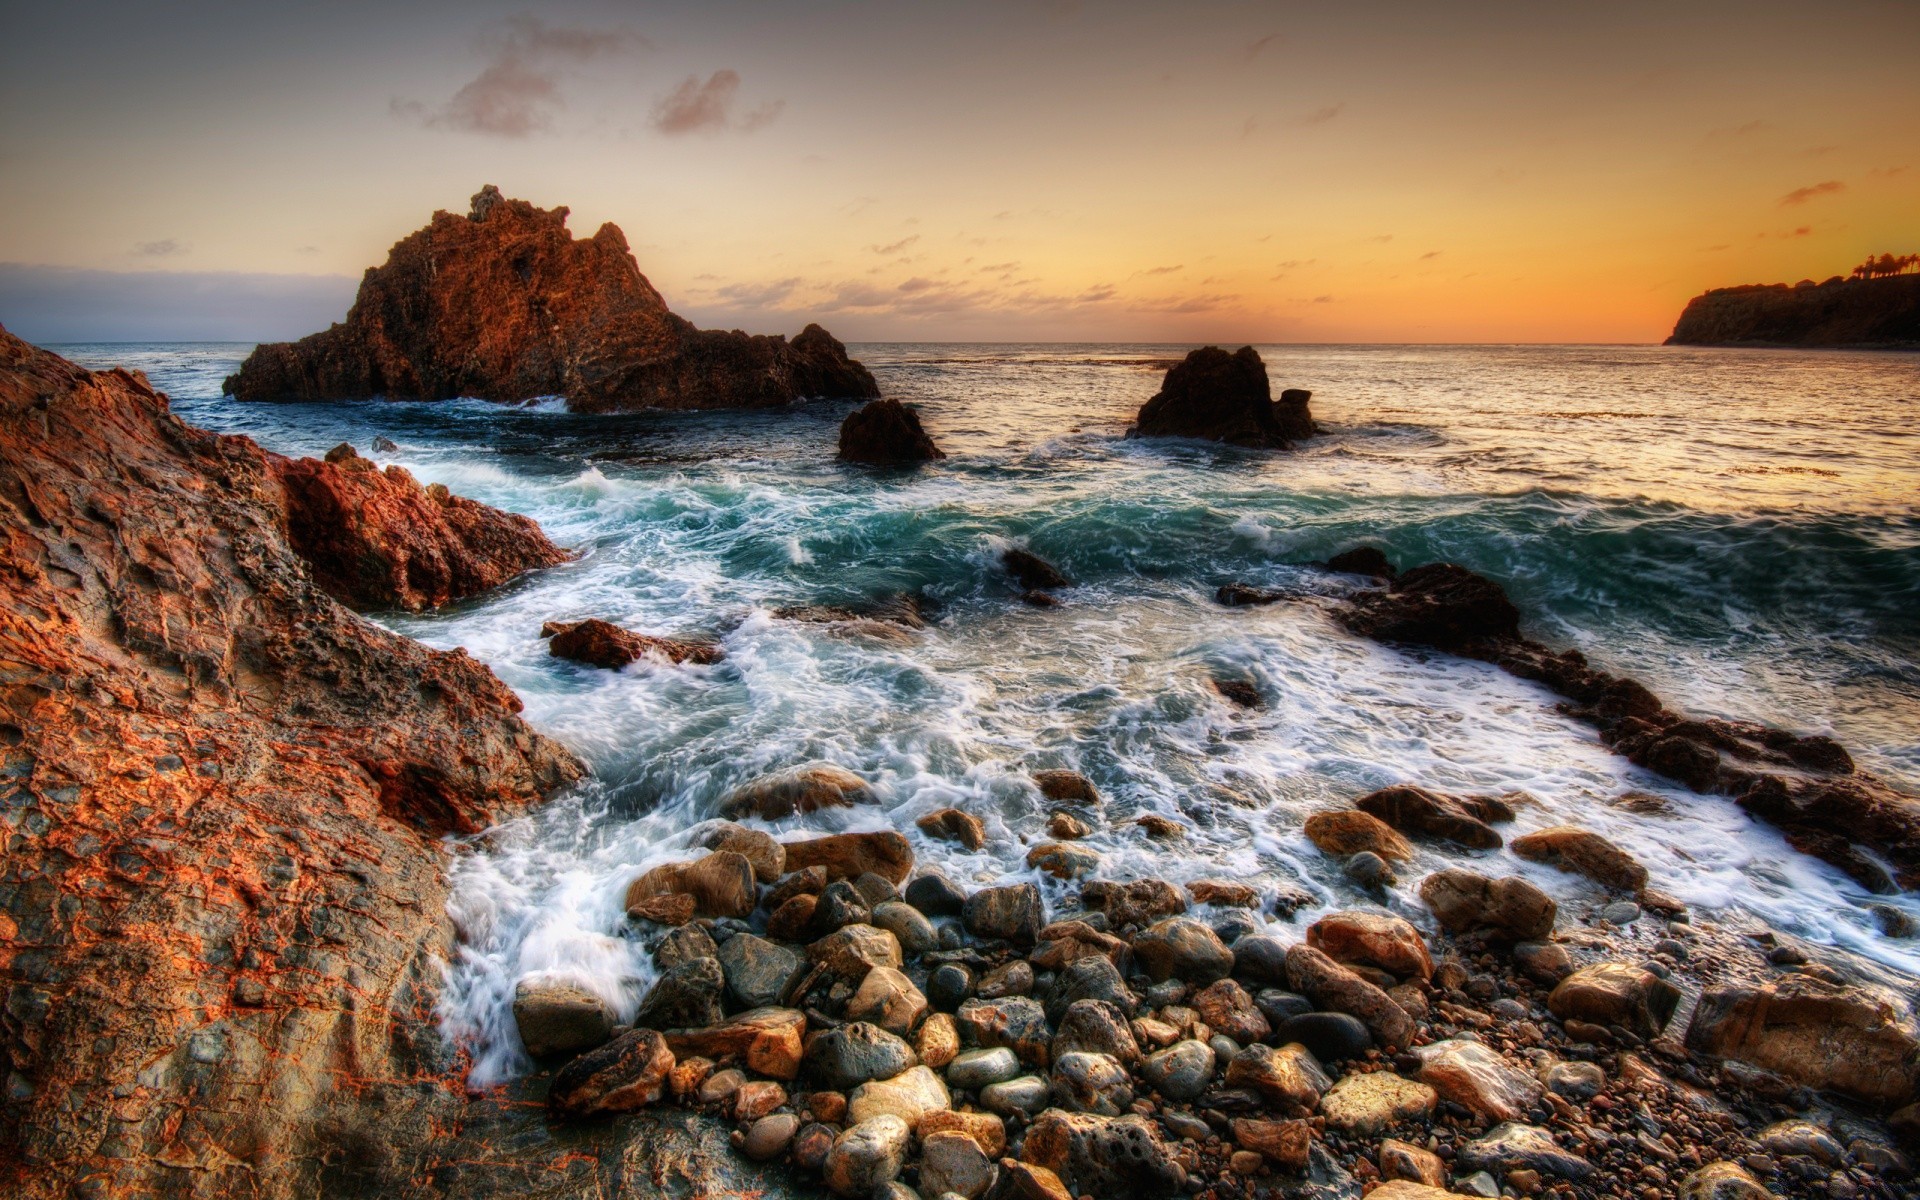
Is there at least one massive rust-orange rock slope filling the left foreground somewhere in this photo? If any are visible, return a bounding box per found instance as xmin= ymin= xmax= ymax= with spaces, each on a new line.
xmin=0 ymin=322 xmax=582 ymax=1196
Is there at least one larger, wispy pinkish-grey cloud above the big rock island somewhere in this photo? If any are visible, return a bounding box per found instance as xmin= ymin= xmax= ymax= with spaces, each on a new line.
xmin=401 ymin=17 xmax=651 ymax=138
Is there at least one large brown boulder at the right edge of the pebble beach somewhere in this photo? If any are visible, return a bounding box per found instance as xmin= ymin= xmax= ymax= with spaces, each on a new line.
xmin=1686 ymin=973 xmax=1920 ymax=1106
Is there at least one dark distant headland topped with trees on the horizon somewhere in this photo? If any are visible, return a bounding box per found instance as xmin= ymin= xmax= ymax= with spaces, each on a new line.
xmin=1667 ymin=275 xmax=1920 ymax=349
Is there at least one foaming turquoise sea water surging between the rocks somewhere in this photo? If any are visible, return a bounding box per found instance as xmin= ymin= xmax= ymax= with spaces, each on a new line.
xmin=63 ymin=346 xmax=1920 ymax=1083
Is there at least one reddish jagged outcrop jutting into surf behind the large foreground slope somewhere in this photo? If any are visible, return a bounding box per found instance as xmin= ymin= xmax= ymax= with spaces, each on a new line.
xmin=267 ymin=444 xmax=570 ymax=612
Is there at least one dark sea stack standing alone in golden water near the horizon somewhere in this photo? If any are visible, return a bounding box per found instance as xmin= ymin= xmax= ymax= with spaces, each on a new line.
xmin=1131 ymin=346 xmax=1319 ymax=449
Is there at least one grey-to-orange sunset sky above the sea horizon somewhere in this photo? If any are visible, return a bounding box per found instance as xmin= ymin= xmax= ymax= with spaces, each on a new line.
xmin=0 ymin=0 xmax=1920 ymax=342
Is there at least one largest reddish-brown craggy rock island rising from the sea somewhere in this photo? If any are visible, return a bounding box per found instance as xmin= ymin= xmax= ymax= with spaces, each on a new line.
xmin=227 ymin=184 xmax=879 ymax=413
